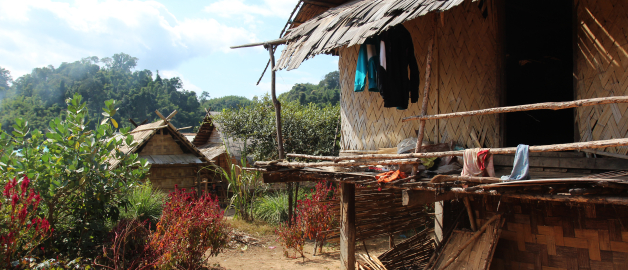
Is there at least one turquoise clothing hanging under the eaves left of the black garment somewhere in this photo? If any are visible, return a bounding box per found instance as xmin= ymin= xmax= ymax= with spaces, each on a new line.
xmin=353 ymin=38 xmax=379 ymax=92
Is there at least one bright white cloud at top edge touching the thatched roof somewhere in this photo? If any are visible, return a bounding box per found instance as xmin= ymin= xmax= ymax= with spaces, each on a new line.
xmin=205 ymin=0 xmax=298 ymax=20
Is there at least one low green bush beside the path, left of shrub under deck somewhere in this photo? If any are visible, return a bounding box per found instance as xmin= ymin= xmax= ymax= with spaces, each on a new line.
xmin=253 ymin=192 xmax=288 ymax=224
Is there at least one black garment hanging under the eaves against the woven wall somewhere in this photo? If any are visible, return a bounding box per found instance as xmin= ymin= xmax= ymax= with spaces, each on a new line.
xmin=377 ymin=25 xmax=420 ymax=110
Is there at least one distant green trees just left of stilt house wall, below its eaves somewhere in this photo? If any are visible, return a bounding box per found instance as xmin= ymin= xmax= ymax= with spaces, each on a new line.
xmin=279 ymin=71 xmax=340 ymax=105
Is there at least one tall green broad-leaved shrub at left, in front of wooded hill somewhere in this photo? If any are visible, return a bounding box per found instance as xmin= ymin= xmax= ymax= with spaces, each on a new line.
xmin=0 ymin=94 xmax=149 ymax=256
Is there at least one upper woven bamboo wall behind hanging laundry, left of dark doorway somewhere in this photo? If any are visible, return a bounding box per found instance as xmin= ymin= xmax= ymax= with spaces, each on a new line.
xmin=339 ymin=0 xmax=500 ymax=150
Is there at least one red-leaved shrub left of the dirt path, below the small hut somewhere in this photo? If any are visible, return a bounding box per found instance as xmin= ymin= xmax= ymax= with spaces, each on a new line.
xmin=149 ymin=189 xmax=230 ymax=269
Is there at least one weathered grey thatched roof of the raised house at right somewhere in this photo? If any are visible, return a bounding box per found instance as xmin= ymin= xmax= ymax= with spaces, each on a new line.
xmin=275 ymin=0 xmax=468 ymax=70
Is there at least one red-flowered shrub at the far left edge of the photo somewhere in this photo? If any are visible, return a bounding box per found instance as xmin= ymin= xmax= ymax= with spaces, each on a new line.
xmin=0 ymin=176 xmax=51 ymax=268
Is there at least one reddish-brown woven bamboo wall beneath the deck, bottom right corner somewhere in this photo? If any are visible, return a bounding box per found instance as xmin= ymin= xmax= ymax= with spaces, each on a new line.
xmin=472 ymin=196 xmax=628 ymax=270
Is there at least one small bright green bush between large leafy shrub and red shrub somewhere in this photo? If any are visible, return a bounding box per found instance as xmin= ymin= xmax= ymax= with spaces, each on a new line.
xmin=120 ymin=181 xmax=168 ymax=225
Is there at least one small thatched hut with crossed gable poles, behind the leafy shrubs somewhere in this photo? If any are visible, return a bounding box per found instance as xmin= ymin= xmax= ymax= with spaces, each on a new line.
xmin=121 ymin=111 xmax=211 ymax=191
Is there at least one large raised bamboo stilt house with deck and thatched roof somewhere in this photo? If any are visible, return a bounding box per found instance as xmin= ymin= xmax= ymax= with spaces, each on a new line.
xmin=237 ymin=0 xmax=628 ymax=269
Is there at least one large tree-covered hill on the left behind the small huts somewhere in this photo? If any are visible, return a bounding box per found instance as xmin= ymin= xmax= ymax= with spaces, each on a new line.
xmin=0 ymin=53 xmax=203 ymax=132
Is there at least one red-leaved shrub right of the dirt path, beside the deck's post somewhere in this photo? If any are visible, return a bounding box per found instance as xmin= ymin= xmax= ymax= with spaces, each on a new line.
xmin=275 ymin=182 xmax=336 ymax=257
